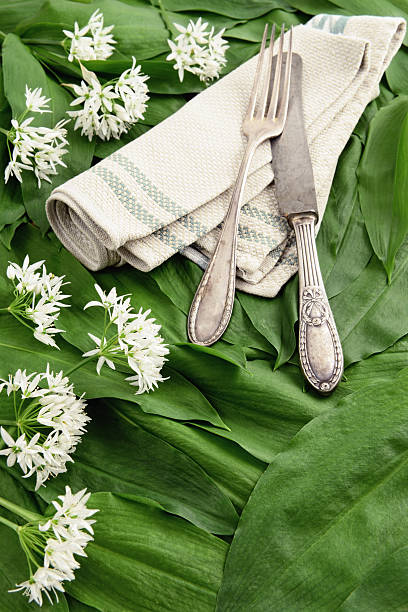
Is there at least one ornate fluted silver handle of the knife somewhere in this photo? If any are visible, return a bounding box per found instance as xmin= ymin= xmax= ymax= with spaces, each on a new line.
xmin=289 ymin=212 xmax=344 ymax=393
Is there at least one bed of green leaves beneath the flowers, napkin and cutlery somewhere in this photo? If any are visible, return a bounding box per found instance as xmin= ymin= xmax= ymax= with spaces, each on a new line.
xmin=0 ymin=0 xmax=408 ymax=612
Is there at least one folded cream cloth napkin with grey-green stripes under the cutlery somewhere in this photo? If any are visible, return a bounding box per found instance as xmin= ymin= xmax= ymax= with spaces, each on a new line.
xmin=46 ymin=15 xmax=405 ymax=297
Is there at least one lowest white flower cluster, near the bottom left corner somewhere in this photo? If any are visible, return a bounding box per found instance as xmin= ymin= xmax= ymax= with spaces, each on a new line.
xmin=10 ymin=486 xmax=98 ymax=606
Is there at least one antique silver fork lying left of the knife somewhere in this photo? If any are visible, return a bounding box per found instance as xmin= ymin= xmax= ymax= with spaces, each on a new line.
xmin=187 ymin=24 xmax=292 ymax=346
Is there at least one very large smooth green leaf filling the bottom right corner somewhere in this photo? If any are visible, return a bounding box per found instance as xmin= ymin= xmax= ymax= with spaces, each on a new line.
xmin=218 ymin=374 xmax=408 ymax=612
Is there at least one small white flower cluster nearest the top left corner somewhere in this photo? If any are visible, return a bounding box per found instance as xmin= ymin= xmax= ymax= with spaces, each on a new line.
xmin=63 ymin=9 xmax=116 ymax=62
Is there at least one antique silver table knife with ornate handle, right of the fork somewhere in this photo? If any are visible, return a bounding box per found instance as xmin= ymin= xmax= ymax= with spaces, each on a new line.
xmin=271 ymin=54 xmax=344 ymax=393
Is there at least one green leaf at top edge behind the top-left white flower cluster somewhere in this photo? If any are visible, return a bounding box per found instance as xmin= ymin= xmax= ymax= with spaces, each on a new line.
xmin=17 ymin=0 xmax=168 ymax=60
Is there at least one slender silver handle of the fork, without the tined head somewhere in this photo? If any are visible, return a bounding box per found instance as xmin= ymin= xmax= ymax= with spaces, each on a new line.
xmin=187 ymin=141 xmax=256 ymax=346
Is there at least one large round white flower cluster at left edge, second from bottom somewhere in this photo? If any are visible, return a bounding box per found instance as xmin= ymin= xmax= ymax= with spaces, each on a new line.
xmin=0 ymin=365 xmax=90 ymax=490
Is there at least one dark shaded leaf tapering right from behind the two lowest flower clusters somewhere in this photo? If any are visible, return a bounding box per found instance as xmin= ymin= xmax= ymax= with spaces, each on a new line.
xmin=39 ymin=402 xmax=238 ymax=534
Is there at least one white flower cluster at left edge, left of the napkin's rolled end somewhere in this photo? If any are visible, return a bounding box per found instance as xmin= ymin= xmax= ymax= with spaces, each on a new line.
xmin=4 ymin=85 xmax=69 ymax=187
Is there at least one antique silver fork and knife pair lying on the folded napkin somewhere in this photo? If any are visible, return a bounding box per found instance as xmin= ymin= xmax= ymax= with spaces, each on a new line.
xmin=187 ymin=25 xmax=343 ymax=393
